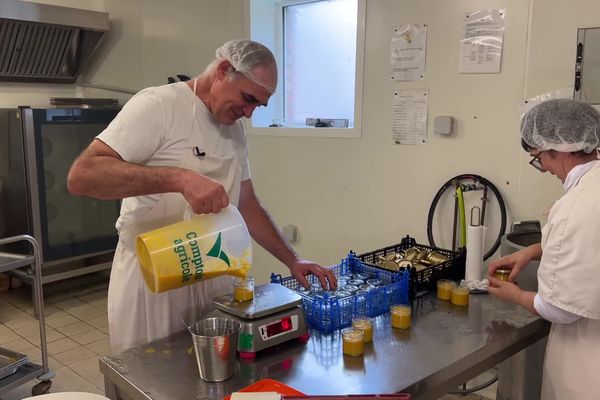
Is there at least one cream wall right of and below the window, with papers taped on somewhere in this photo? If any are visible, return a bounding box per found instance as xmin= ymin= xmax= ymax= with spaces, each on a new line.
xmin=244 ymin=0 xmax=600 ymax=280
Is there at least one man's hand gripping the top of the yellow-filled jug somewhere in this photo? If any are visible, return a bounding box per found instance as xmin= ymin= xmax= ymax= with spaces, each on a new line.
xmin=181 ymin=171 xmax=229 ymax=214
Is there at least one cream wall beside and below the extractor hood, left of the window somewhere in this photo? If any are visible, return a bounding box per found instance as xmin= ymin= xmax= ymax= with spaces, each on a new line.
xmin=0 ymin=0 xmax=244 ymax=107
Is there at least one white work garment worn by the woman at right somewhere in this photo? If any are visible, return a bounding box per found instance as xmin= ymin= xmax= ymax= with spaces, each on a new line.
xmin=538 ymin=162 xmax=600 ymax=400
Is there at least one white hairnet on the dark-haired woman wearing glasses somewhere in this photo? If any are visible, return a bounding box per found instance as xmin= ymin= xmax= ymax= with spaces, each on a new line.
xmin=521 ymin=99 xmax=600 ymax=153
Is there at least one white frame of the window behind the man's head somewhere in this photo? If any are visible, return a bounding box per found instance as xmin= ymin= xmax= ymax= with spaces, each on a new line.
xmin=243 ymin=0 xmax=366 ymax=138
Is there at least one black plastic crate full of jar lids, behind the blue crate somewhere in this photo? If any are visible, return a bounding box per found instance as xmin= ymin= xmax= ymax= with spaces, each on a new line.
xmin=356 ymin=235 xmax=466 ymax=300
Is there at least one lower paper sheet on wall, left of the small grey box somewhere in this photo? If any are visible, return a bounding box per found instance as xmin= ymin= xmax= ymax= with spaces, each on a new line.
xmin=392 ymin=90 xmax=429 ymax=144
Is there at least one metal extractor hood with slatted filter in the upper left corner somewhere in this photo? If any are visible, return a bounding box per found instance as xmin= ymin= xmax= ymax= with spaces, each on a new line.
xmin=0 ymin=0 xmax=109 ymax=83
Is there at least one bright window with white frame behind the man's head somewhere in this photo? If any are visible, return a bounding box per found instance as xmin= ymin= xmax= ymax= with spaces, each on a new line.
xmin=250 ymin=0 xmax=365 ymax=137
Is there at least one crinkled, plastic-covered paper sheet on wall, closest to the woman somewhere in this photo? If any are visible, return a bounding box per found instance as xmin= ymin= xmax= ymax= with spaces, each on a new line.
xmin=458 ymin=10 xmax=506 ymax=73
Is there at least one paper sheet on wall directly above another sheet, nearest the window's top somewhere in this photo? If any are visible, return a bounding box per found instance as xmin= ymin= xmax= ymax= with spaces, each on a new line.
xmin=390 ymin=24 xmax=427 ymax=81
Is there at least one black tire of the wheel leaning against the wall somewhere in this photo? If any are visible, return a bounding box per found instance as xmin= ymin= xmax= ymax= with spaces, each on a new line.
xmin=427 ymin=174 xmax=506 ymax=260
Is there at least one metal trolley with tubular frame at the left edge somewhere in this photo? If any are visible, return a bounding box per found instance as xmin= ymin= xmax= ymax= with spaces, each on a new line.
xmin=0 ymin=235 xmax=55 ymax=396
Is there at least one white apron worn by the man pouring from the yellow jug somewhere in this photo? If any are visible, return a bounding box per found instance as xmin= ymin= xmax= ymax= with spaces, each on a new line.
xmin=108 ymin=138 xmax=241 ymax=352
